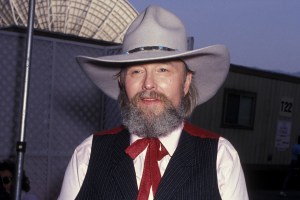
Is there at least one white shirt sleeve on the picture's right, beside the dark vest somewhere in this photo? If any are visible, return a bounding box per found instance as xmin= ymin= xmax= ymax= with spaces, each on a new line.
xmin=217 ymin=137 xmax=249 ymax=200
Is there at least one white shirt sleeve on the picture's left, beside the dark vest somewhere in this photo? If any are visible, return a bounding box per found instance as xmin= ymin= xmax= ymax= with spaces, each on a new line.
xmin=58 ymin=135 xmax=93 ymax=200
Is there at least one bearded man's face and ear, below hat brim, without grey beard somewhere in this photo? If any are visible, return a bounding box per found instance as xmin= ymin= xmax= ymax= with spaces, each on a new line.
xmin=124 ymin=61 xmax=192 ymax=115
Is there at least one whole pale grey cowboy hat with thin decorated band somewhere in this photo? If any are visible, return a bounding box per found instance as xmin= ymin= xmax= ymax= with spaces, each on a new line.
xmin=77 ymin=6 xmax=229 ymax=105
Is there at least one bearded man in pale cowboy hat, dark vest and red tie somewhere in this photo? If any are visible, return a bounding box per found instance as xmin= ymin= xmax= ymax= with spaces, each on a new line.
xmin=59 ymin=6 xmax=248 ymax=200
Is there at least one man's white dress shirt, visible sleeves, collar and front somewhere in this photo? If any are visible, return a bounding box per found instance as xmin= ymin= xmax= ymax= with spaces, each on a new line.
xmin=58 ymin=126 xmax=248 ymax=200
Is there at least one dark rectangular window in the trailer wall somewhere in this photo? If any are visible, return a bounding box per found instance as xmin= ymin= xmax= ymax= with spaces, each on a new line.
xmin=222 ymin=89 xmax=256 ymax=129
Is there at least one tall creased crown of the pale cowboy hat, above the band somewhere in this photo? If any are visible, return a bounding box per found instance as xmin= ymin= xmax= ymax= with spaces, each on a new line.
xmin=122 ymin=6 xmax=187 ymax=52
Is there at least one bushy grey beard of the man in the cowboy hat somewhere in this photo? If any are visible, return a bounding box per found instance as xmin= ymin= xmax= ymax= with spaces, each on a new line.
xmin=121 ymin=91 xmax=185 ymax=138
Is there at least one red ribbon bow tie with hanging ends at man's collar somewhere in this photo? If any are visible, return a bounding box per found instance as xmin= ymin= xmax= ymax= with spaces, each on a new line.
xmin=125 ymin=138 xmax=168 ymax=200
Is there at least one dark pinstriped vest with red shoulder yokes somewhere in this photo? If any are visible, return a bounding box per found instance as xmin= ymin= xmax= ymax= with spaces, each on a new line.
xmin=76 ymin=123 xmax=221 ymax=200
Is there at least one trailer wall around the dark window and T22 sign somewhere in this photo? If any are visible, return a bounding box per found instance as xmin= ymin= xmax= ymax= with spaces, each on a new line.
xmin=191 ymin=67 xmax=300 ymax=165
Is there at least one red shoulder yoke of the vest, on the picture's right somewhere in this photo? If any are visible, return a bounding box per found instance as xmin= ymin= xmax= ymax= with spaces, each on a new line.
xmin=183 ymin=122 xmax=220 ymax=139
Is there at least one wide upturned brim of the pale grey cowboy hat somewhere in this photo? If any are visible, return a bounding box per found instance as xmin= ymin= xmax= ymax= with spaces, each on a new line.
xmin=77 ymin=45 xmax=230 ymax=105
